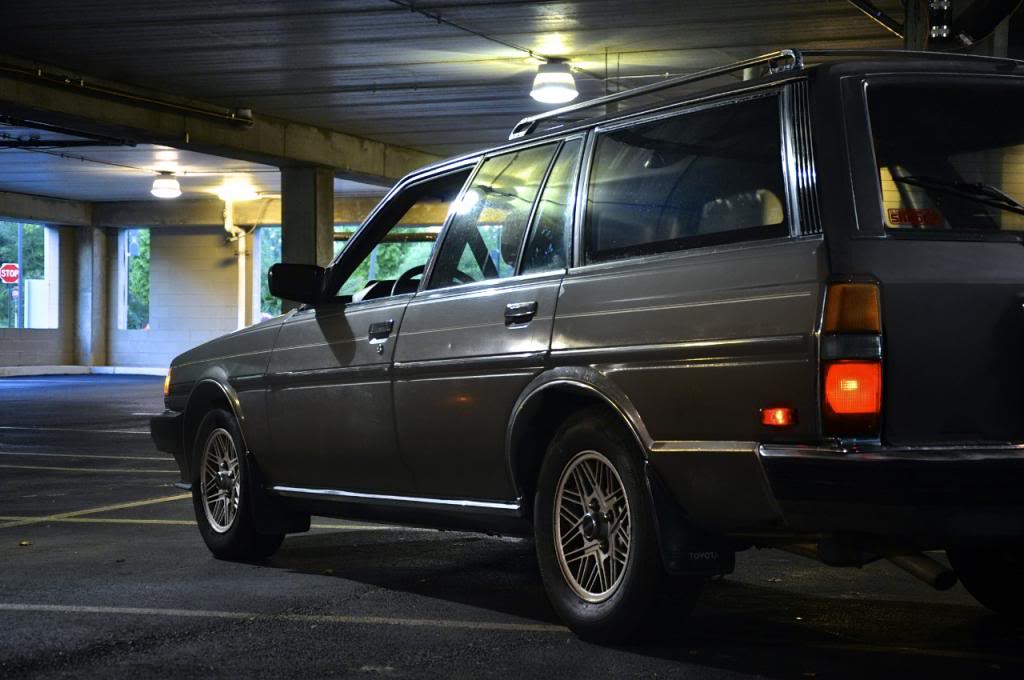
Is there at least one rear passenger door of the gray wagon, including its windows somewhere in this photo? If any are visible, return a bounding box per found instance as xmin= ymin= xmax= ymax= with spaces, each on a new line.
xmin=394 ymin=138 xmax=582 ymax=500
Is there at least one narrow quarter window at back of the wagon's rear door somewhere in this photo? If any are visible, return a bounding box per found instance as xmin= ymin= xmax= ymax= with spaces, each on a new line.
xmin=521 ymin=138 xmax=583 ymax=273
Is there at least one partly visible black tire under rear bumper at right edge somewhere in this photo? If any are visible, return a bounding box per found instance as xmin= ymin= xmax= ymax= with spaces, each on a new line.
xmin=946 ymin=547 xmax=1024 ymax=618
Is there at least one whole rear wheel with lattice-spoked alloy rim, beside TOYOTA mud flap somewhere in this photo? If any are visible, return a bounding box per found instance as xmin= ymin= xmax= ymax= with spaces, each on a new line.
xmin=534 ymin=409 xmax=695 ymax=643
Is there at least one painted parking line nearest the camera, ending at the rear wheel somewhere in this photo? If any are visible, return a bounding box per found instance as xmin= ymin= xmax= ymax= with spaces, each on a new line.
xmin=0 ymin=602 xmax=568 ymax=635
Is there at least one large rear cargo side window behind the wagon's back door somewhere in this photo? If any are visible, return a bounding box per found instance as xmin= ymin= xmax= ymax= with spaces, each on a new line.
xmin=584 ymin=96 xmax=790 ymax=263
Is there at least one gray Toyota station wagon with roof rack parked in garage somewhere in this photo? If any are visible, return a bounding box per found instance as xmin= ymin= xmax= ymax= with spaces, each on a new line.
xmin=152 ymin=50 xmax=1024 ymax=641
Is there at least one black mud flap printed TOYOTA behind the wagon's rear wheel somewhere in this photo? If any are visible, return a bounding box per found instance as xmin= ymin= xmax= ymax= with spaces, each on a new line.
xmin=644 ymin=463 xmax=736 ymax=577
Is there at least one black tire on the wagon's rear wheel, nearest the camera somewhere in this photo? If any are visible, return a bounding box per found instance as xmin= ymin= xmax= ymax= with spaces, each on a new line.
xmin=534 ymin=409 xmax=702 ymax=643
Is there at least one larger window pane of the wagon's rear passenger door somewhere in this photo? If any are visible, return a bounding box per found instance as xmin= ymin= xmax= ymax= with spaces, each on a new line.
xmin=429 ymin=143 xmax=558 ymax=289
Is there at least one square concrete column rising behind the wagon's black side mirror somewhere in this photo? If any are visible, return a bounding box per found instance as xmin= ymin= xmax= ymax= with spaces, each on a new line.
xmin=281 ymin=166 xmax=334 ymax=266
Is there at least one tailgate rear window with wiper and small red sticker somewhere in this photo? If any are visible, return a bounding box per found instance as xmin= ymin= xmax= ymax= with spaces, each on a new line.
xmin=868 ymin=83 xmax=1024 ymax=232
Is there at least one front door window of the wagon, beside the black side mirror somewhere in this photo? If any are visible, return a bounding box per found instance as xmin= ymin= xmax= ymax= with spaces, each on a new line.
xmin=338 ymin=169 xmax=470 ymax=302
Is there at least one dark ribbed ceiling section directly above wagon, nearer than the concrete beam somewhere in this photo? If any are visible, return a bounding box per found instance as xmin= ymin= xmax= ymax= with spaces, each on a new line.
xmin=0 ymin=0 xmax=902 ymax=158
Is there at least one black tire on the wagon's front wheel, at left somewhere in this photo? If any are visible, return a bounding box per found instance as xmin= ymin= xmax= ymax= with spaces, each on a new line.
xmin=191 ymin=409 xmax=285 ymax=561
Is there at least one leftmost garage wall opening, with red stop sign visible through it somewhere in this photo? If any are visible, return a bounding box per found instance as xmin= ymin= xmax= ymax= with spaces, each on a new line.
xmin=0 ymin=221 xmax=59 ymax=329
